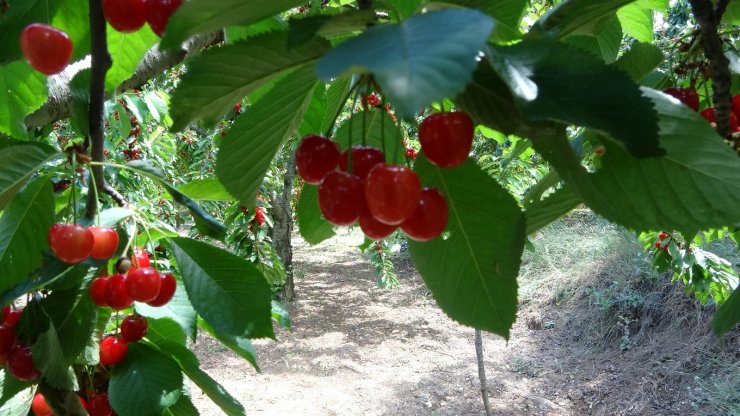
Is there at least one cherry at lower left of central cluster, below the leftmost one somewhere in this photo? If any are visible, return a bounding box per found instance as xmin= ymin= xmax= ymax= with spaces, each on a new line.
xmin=319 ymin=170 xmax=363 ymax=225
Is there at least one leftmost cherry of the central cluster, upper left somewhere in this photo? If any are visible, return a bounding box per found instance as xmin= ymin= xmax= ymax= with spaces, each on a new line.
xmin=295 ymin=134 xmax=339 ymax=185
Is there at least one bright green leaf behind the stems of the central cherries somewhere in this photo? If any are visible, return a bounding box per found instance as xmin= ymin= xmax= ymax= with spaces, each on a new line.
xmin=334 ymin=109 xmax=405 ymax=164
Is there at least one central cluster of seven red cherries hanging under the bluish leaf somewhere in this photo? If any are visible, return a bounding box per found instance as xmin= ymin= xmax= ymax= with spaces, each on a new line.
xmin=296 ymin=112 xmax=474 ymax=241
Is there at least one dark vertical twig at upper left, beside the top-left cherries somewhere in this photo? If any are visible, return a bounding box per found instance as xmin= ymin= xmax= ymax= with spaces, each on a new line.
xmin=85 ymin=0 xmax=111 ymax=219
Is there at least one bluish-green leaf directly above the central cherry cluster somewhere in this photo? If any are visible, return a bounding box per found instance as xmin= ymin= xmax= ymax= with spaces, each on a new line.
xmin=316 ymin=9 xmax=494 ymax=118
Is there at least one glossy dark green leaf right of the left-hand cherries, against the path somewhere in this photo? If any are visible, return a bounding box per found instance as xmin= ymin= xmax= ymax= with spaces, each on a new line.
xmin=171 ymin=238 xmax=274 ymax=338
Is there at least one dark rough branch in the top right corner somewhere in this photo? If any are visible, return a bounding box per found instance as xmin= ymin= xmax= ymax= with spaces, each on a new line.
xmin=689 ymin=0 xmax=740 ymax=153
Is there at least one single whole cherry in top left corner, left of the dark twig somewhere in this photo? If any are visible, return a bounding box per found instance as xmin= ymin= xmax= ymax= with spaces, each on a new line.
xmin=21 ymin=23 xmax=72 ymax=75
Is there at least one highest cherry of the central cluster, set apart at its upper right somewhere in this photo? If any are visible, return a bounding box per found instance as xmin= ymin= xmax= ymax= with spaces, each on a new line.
xmin=419 ymin=111 xmax=474 ymax=168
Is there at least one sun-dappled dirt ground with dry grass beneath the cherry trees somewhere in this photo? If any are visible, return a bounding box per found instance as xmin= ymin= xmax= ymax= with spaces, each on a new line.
xmin=193 ymin=232 xmax=738 ymax=415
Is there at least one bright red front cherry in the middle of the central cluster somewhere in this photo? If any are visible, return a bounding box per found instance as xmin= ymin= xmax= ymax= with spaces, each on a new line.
xmin=365 ymin=163 xmax=421 ymax=225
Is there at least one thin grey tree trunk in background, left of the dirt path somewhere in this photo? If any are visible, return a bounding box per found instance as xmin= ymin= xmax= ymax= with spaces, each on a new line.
xmin=272 ymin=153 xmax=295 ymax=302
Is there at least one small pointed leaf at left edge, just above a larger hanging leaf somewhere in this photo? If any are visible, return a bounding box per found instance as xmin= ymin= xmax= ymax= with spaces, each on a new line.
xmin=0 ymin=141 xmax=59 ymax=210
